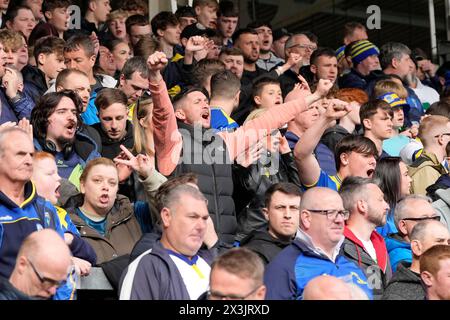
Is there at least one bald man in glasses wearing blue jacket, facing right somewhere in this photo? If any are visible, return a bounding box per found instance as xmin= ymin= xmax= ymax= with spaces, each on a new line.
xmin=264 ymin=187 xmax=372 ymax=300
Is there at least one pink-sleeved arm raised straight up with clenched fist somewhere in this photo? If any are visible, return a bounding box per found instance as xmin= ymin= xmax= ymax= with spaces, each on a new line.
xmin=147 ymin=52 xmax=182 ymax=176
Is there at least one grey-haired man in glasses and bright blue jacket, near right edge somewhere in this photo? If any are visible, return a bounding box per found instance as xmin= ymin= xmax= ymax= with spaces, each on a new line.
xmin=385 ymin=195 xmax=441 ymax=272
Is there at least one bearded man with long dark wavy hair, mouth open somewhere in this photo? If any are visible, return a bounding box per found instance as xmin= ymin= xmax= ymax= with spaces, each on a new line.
xmin=31 ymin=90 xmax=100 ymax=187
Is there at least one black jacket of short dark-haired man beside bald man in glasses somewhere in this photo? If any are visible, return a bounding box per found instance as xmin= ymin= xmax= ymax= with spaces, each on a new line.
xmin=241 ymin=230 xmax=292 ymax=265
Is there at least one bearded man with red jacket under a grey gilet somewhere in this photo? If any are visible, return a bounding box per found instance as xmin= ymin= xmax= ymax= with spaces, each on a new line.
xmin=339 ymin=177 xmax=392 ymax=299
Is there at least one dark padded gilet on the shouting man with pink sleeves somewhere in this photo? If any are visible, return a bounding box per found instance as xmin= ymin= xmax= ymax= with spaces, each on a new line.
xmin=172 ymin=122 xmax=237 ymax=245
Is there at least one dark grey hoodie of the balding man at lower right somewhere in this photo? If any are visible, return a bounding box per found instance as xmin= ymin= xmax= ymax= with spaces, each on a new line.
xmin=381 ymin=261 xmax=425 ymax=300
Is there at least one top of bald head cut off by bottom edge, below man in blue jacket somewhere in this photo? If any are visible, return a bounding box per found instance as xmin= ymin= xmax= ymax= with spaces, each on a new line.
xmin=303 ymin=275 xmax=367 ymax=300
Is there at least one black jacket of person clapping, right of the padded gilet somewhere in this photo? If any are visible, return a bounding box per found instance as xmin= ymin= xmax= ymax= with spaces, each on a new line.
xmin=233 ymin=152 xmax=300 ymax=240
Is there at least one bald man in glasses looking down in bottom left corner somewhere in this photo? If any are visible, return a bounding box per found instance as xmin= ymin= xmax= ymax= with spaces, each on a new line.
xmin=0 ymin=229 xmax=73 ymax=300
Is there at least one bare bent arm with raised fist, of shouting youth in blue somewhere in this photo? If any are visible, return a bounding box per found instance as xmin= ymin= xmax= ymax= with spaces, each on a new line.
xmin=294 ymin=99 xmax=350 ymax=187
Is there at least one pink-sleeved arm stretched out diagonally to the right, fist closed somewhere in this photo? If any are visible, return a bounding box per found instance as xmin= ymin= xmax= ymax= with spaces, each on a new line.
xmin=219 ymin=80 xmax=332 ymax=160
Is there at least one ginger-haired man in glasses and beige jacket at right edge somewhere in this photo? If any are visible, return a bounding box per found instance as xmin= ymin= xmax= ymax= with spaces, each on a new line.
xmin=408 ymin=116 xmax=450 ymax=195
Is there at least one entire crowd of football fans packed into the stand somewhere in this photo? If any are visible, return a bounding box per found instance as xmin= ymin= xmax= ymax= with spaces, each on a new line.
xmin=0 ymin=0 xmax=450 ymax=300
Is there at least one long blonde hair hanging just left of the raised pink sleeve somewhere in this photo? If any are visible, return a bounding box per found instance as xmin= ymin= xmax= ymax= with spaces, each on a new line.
xmin=132 ymin=98 xmax=155 ymax=157
